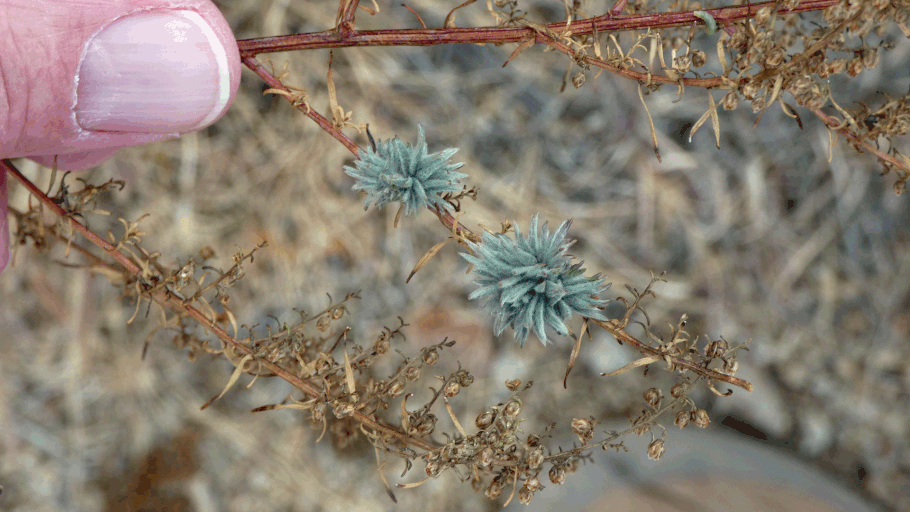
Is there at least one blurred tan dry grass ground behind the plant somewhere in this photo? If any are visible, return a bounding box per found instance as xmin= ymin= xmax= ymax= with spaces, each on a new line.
xmin=0 ymin=0 xmax=910 ymax=511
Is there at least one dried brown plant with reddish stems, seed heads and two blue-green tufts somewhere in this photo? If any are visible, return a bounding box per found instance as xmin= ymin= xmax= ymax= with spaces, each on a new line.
xmin=4 ymin=0 xmax=910 ymax=503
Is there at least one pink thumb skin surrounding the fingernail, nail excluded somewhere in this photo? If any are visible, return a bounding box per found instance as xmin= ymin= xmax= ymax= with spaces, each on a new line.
xmin=0 ymin=0 xmax=240 ymax=168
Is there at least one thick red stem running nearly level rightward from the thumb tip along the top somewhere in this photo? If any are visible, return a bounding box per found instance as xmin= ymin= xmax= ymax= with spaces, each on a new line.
xmin=237 ymin=0 xmax=838 ymax=56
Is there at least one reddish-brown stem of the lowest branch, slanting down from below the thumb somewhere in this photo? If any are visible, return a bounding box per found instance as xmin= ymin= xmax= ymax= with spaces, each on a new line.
xmin=0 ymin=160 xmax=437 ymax=453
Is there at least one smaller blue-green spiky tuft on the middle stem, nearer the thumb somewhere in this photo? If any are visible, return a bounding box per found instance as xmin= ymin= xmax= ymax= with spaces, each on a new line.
xmin=344 ymin=125 xmax=467 ymax=215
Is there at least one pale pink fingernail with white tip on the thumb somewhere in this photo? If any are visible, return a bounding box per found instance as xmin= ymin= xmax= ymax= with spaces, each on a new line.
xmin=75 ymin=11 xmax=230 ymax=133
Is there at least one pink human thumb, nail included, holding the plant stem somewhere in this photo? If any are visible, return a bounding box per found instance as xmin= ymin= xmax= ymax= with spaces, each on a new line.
xmin=0 ymin=0 xmax=240 ymax=169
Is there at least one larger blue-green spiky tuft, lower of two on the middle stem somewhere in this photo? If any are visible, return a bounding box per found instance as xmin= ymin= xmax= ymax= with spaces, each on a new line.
xmin=461 ymin=215 xmax=610 ymax=346
